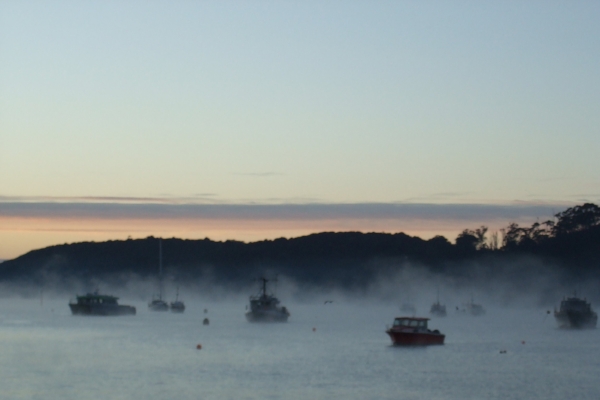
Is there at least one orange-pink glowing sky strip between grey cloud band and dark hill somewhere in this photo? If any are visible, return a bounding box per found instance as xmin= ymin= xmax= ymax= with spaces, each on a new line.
xmin=0 ymin=217 xmax=506 ymax=259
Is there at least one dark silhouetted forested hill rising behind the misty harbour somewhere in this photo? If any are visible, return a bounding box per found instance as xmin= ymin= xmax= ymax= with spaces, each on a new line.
xmin=0 ymin=203 xmax=600 ymax=288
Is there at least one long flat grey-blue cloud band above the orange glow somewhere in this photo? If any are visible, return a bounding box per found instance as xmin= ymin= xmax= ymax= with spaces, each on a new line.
xmin=0 ymin=197 xmax=564 ymax=222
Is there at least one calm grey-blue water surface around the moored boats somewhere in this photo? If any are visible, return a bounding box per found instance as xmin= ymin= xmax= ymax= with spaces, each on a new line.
xmin=0 ymin=299 xmax=600 ymax=400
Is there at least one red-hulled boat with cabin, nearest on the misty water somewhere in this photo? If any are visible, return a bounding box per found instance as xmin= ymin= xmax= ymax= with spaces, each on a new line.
xmin=385 ymin=317 xmax=446 ymax=346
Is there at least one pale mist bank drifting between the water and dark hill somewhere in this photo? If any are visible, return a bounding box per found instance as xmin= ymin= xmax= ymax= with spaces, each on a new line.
xmin=0 ymin=256 xmax=600 ymax=314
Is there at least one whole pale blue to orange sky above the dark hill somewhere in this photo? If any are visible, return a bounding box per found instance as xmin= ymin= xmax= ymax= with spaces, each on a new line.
xmin=0 ymin=0 xmax=600 ymax=259
